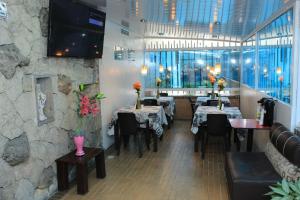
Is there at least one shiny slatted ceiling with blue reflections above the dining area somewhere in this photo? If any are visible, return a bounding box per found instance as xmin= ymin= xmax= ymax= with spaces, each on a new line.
xmin=128 ymin=0 xmax=294 ymax=37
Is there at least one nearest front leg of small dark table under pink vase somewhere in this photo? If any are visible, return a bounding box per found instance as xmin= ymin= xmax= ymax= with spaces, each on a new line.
xmin=76 ymin=163 xmax=89 ymax=194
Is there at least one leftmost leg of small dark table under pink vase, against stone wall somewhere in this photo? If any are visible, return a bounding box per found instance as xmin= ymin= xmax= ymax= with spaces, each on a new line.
xmin=56 ymin=161 xmax=69 ymax=191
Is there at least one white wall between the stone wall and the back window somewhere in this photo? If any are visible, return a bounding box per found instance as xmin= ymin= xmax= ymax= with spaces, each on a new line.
xmin=99 ymin=0 xmax=143 ymax=148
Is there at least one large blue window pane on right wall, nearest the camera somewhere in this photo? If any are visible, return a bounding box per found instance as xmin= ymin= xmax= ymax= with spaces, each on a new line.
xmin=258 ymin=10 xmax=293 ymax=103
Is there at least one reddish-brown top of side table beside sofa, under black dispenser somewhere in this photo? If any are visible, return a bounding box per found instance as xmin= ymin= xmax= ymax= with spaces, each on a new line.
xmin=229 ymin=119 xmax=271 ymax=130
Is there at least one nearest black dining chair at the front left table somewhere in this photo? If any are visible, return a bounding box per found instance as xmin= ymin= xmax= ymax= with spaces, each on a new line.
xmin=115 ymin=113 xmax=150 ymax=158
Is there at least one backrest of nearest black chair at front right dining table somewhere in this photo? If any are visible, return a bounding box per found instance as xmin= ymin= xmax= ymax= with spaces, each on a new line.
xmin=207 ymin=114 xmax=229 ymax=136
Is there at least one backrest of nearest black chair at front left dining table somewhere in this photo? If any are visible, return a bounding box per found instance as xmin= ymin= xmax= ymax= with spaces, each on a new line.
xmin=118 ymin=113 xmax=138 ymax=135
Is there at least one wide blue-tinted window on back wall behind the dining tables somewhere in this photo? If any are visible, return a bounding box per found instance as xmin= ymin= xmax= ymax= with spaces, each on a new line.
xmin=145 ymin=49 xmax=240 ymax=88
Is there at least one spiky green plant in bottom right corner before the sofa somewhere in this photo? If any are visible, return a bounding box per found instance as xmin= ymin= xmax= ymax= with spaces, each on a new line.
xmin=265 ymin=179 xmax=300 ymax=200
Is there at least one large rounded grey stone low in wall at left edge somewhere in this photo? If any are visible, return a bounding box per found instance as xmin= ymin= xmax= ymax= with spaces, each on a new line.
xmin=2 ymin=133 xmax=29 ymax=166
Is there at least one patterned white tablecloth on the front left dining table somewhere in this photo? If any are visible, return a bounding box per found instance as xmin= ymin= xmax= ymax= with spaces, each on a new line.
xmin=113 ymin=106 xmax=168 ymax=136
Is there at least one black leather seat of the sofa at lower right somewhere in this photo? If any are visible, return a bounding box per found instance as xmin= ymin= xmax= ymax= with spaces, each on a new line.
xmin=226 ymin=152 xmax=281 ymax=200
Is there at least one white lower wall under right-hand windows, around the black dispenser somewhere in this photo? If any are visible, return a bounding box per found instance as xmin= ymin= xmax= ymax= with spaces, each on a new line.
xmin=240 ymin=85 xmax=292 ymax=151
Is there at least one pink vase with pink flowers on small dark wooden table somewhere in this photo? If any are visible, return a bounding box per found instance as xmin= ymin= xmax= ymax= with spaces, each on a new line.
xmin=73 ymin=84 xmax=105 ymax=156
